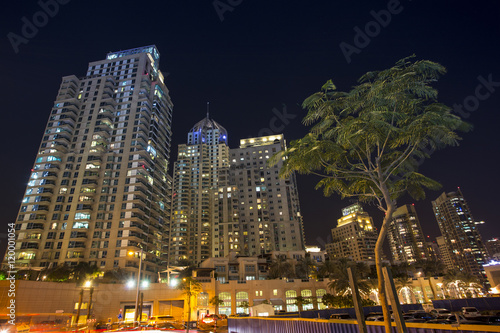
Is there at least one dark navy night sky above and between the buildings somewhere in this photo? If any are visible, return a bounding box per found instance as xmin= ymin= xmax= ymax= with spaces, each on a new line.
xmin=0 ymin=0 xmax=500 ymax=254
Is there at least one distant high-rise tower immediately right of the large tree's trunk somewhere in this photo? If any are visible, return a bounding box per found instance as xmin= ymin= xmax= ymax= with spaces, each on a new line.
xmin=387 ymin=205 xmax=429 ymax=264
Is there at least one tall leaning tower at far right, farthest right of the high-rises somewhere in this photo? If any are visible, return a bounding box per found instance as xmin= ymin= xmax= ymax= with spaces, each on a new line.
xmin=432 ymin=188 xmax=487 ymax=281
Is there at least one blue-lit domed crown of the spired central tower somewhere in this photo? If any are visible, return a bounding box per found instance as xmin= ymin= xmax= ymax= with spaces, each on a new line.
xmin=188 ymin=114 xmax=227 ymax=145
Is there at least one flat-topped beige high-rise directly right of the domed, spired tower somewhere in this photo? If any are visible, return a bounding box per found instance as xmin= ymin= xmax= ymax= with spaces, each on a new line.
xmin=222 ymin=134 xmax=305 ymax=257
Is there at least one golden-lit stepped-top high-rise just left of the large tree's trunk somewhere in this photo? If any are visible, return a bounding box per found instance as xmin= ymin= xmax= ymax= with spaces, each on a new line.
xmin=326 ymin=203 xmax=377 ymax=261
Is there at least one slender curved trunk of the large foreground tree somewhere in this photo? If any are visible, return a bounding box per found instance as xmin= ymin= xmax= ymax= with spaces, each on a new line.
xmin=375 ymin=182 xmax=395 ymax=333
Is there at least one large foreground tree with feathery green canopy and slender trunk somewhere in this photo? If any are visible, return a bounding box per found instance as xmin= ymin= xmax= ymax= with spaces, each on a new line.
xmin=270 ymin=57 xmax=469 ymax=333
